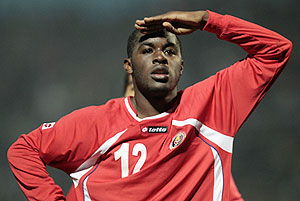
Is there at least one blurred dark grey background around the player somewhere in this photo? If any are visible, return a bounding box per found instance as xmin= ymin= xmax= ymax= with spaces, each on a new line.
xmin=0 ymin=0 xmax=300 ymax=201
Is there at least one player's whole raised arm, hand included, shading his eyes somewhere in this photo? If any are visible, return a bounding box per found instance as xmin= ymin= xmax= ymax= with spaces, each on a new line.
xmin=135 ymin=11 xmax=292 ymax=136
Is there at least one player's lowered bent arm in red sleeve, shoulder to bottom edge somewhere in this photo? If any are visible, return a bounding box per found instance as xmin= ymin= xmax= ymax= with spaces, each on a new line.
xmin=7 ymin=107 xmax=97 ymax=201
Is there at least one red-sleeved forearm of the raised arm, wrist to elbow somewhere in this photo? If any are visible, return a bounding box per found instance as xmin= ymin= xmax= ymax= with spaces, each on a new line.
xmin=203 ymin=11 xmax=292 ymax=67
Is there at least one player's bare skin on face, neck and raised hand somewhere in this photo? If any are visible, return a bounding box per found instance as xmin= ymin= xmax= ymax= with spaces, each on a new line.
xmin=124 ymin=11 xmax=209 ymax=118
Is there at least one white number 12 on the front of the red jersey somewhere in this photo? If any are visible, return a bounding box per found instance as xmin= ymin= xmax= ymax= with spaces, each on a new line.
xmin=114 ymin=143 xmax=147 ymax=178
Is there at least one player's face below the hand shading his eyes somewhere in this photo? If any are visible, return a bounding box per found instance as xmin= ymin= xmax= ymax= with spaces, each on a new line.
xmin=125 ymin=32 xmax=183 ymax=96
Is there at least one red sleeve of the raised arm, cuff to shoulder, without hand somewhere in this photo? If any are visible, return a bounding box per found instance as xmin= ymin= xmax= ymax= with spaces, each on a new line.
xmin=195 ymin=11 xmax=292 ymax=136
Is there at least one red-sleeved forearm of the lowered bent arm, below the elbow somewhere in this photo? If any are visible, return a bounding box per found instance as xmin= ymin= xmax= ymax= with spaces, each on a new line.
xmin=7 ymin=136 xmax=65 ymax=201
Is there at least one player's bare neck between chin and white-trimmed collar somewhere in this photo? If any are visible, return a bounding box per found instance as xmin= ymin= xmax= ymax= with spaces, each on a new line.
xmin=132 ymin=90 xmax=177 ymax=118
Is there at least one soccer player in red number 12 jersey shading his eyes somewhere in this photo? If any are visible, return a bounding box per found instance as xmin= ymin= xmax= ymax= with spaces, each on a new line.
xmin=8 ymin=11 xmax=292 ymax=201
